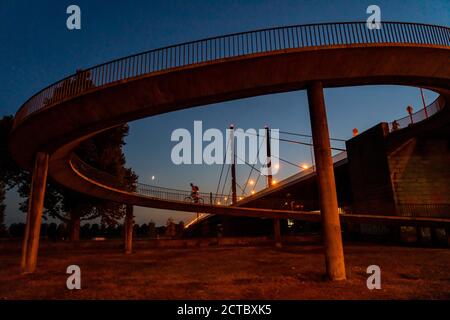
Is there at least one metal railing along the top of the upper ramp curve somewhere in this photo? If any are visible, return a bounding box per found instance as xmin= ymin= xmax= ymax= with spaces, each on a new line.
xmin=15 ymin=22 xmax=450 ymax=126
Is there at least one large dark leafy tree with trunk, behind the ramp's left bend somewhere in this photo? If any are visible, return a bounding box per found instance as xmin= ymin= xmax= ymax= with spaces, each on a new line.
xmin=44 ymin=70 xmax=137 ymax=241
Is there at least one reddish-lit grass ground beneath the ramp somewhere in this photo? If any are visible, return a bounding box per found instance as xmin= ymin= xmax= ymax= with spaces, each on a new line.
xmin=0 ymin=243 xmax=450 ymax=299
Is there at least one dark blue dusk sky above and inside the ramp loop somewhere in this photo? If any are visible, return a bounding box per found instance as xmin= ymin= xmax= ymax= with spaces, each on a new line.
xmin=0 ymin=0 xmax=450 ymax=223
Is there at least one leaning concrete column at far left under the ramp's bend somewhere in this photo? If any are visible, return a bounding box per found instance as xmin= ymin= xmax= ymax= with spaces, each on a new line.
xmin=21 ymin=152 xmax=49 ymax=273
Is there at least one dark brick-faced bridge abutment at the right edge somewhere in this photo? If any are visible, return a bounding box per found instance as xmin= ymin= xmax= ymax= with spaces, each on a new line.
xmin=347 ymin=123 xmax=450 ymax=217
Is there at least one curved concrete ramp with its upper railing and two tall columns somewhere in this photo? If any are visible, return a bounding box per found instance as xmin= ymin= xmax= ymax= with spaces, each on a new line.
xmin=10 ymin=22 xmax=450 ymax=280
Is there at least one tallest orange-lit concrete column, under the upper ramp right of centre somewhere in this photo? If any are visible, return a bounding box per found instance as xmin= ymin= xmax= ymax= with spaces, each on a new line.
xmin=307 ymin=81 xmax=346 ymax=280
